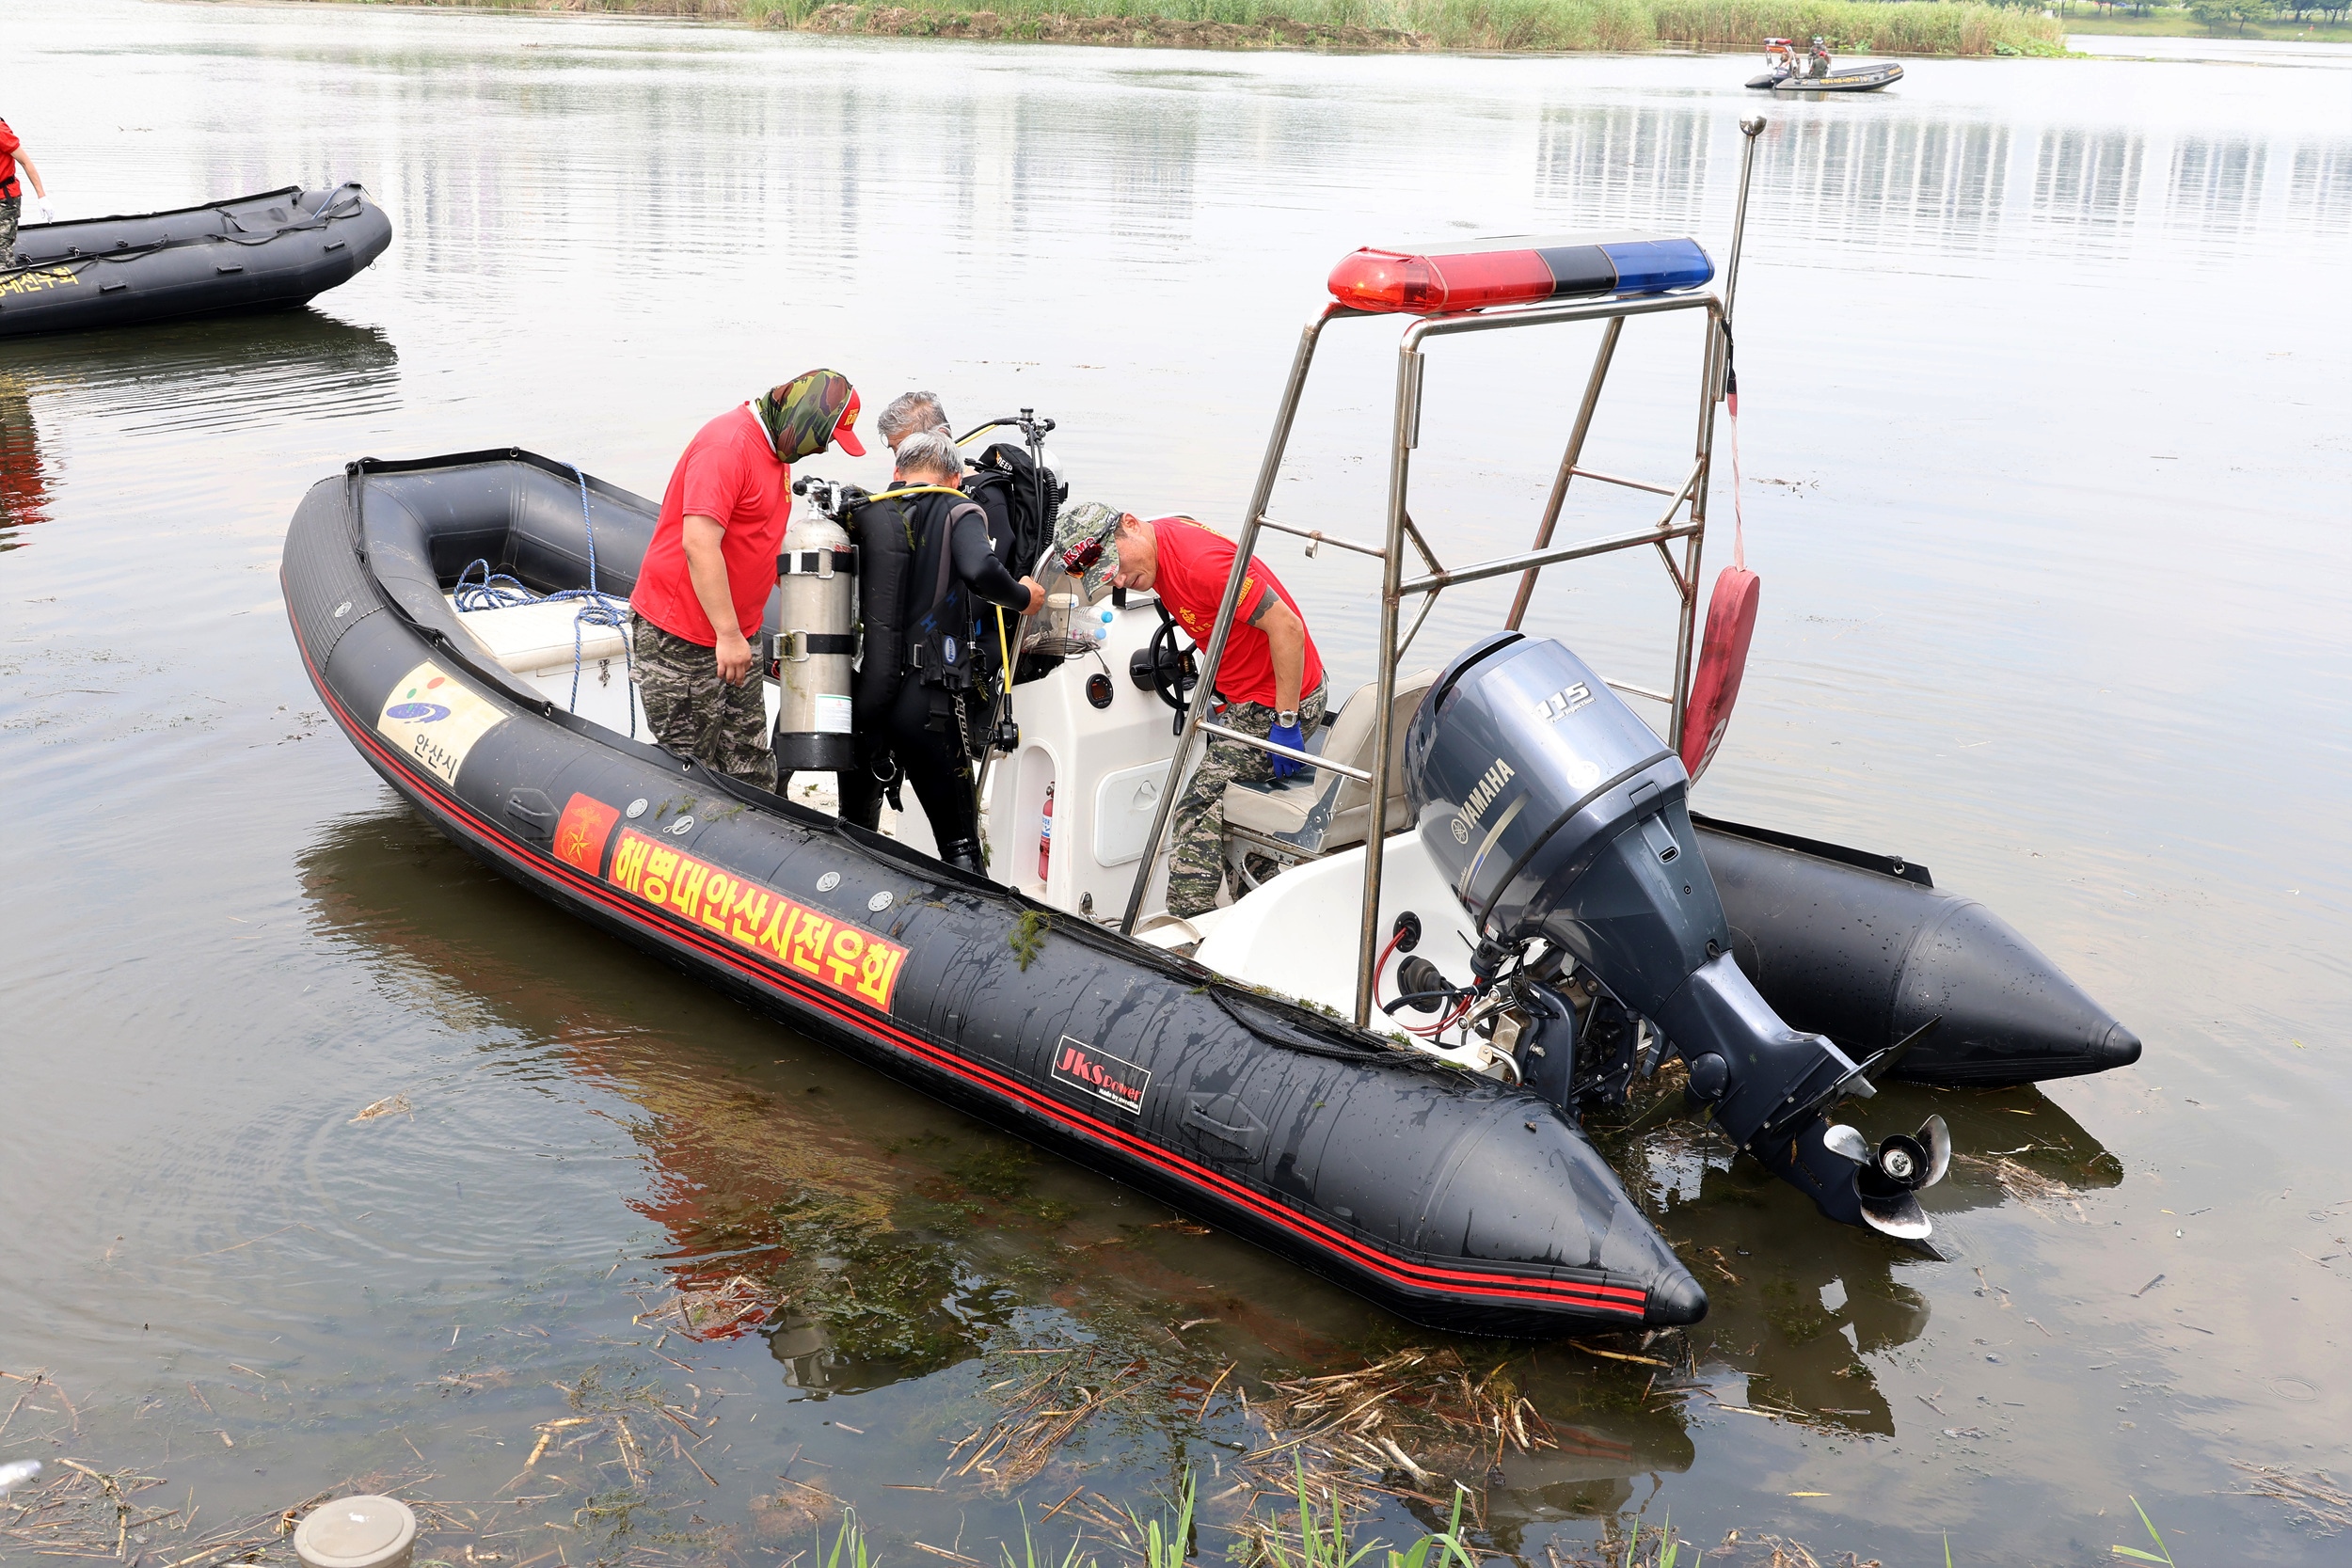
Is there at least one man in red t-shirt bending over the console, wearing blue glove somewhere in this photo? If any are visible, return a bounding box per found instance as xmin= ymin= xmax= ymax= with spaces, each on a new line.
xmin=1110 ymin=515 xmax=1325 ymax=919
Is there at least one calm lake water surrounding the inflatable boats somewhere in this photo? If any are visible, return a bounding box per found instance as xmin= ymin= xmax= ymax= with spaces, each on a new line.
xmin=0 ymin=12 xmax=2352 ymax=1568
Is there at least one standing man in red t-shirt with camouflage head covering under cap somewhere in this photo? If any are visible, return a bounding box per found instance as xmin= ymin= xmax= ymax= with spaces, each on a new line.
xmin=628 ymin=369 xmax=866 ymax=790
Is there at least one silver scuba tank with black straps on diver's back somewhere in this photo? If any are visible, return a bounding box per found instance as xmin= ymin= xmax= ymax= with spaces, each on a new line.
xmin=771 ymin=480 xmax=859 ymax=773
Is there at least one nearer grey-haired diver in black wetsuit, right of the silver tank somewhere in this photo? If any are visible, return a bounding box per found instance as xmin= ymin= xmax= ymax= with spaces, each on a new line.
xmin=861 ymin=428 xmax=1044 ymax=877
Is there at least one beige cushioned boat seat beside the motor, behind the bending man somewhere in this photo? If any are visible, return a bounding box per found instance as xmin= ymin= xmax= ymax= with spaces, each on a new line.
xmin=1226 ymin=670 xmax=1438 ymax=889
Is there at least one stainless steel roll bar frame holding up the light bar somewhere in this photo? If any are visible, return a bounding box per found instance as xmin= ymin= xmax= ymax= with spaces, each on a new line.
xmin=1120 ymin=118 xmax=1764 ymax=1030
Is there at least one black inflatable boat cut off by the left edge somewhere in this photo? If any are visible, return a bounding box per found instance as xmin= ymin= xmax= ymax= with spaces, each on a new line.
xmin=0 ymin=183 xmax=393 ymax=336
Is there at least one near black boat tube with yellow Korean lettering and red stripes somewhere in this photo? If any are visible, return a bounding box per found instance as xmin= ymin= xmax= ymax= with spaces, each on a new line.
xmin=282 ymin=451 xmax=1706 ymax=1336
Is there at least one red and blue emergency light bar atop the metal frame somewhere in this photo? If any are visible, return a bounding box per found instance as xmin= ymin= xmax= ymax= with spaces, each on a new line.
xmin=1331 ymin=232 xmax=1715 ymax=315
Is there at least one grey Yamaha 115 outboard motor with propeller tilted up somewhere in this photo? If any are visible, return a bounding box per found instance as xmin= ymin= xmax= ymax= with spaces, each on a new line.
xmin=1405 ymin=632 xmax=1950 ymax=1239
